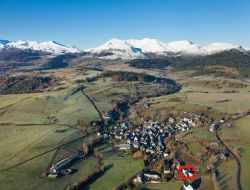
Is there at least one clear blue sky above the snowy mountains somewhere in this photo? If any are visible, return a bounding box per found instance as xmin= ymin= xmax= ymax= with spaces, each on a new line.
xmin=0 ymin=0 xmax=250 ymax=48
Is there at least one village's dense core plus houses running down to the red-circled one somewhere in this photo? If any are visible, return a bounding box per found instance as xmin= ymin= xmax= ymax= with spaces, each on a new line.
xmin=97 ymin=113 xmax=202 ymax=189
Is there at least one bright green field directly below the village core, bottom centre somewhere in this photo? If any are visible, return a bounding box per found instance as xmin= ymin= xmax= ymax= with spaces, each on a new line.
xmin=83 ymin=147 xmax=143 ymax=190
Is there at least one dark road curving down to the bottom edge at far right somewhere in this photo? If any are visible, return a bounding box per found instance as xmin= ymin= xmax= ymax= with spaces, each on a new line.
xmin=216 ymin=129 xmax=243 ymax=190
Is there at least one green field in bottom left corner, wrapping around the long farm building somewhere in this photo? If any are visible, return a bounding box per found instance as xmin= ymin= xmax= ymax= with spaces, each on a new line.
xmin=0 ymin=152 xmax=98 ymax=190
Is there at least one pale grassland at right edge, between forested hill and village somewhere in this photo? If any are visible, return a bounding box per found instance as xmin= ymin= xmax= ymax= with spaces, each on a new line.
xmin=150 ymin=77 xmax=250 ymax=113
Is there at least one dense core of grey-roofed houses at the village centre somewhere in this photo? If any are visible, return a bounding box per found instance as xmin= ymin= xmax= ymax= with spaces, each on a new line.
xmin=98 ymin=117 xmax=196 ymax=154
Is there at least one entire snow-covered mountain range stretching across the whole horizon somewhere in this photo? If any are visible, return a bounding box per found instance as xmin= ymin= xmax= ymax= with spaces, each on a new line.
xmin=0 ymin=38 xmax=249 ymax=59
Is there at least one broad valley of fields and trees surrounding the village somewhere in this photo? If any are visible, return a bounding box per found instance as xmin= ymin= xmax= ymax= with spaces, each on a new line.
xmin=0 ymin=53 xmax=250 ymax=190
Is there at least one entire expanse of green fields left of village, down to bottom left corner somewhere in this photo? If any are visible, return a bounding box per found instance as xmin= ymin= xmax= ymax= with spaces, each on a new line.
xmin=0 ymin=88 xmax=102 ymax=190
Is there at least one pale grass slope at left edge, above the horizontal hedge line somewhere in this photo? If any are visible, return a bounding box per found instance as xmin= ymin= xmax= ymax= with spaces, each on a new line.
xmin=0 ymin=89 xmax=99 ymax=125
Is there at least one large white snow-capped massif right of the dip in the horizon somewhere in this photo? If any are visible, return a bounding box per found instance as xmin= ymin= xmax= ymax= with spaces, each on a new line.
xmin=85 ymin=38 xmax=246 ymax=59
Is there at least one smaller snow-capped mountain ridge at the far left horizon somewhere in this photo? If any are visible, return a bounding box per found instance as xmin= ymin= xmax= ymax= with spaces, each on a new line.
xmin=0 ymin=40 xmax=81 ymax=54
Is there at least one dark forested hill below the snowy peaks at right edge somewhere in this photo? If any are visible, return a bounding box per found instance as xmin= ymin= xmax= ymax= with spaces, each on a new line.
xmin=128 ymin=50 xmax=250 ymax=78
